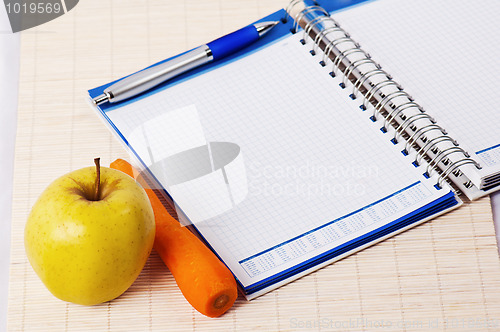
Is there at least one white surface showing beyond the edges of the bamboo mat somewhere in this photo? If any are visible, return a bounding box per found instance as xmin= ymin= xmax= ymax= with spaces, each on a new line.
xmin=0 ymin=5 xmax=500 ymax=331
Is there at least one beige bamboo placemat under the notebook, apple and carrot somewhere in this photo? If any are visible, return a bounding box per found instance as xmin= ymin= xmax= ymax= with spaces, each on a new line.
xmin=8 ymin=0 xmax=500 ymax=331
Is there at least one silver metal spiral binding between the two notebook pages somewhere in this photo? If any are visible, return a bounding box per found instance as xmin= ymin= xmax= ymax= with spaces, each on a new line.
xmin=288 ymin=0 xmax=481 ymax=192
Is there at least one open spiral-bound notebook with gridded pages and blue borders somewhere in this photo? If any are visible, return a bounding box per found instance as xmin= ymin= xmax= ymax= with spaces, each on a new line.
xmin=89 ymin=0 xmax=500 ymax=299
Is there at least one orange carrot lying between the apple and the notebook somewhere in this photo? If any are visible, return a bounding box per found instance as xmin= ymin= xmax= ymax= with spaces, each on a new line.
xmin=110 ymin=159 xmax=238 ymax=317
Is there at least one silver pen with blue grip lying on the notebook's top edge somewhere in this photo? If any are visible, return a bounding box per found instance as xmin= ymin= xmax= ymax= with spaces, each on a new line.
xmin=93 ymin=21 xmax=279 ymax=105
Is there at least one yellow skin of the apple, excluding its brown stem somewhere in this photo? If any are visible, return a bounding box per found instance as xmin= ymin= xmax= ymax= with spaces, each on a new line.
xmin=24 ymin=167 xmax=155 ymax=305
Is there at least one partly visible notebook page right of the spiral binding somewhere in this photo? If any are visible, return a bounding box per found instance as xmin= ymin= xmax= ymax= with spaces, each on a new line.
xmin=333 ymin=0 xmax=500 ymax=178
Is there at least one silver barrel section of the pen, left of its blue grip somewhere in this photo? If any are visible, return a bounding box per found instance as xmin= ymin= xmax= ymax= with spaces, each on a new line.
xmin=104 ymin=45 xmax=213 ymax=102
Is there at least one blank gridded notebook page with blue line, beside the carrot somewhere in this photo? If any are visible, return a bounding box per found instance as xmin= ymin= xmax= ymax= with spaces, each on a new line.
xmin=106 ymin=34 xmax=449 ymax=286
